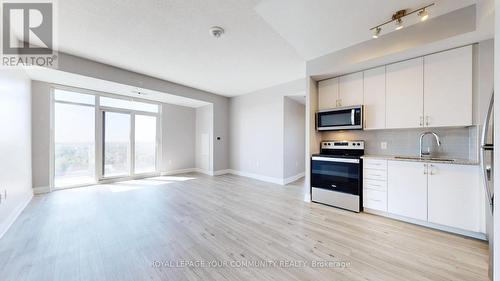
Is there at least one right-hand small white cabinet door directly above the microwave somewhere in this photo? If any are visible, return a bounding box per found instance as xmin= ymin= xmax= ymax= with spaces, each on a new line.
xmin=339 ymin=72 xmax=363 ymax=106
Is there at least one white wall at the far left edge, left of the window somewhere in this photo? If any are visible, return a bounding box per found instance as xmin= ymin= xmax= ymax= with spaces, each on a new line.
xmin=0 ymin=69 xmax=33 ymax=237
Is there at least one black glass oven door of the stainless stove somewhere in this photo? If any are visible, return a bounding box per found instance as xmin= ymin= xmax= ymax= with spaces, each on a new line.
xmin=311 ymin=156 xmax=361 ymax=196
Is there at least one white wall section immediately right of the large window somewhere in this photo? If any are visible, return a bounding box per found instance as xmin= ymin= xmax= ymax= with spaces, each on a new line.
xmin=161 ymin=104 xmax=196 ymax=173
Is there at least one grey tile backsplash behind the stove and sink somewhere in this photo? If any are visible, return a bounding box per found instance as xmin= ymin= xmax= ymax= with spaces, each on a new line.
xmin=321 ymin=126 xmax=479 ymax=160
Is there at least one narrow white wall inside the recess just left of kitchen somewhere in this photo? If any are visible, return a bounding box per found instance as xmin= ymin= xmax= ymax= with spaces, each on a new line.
xmin=283 ymin=97 xmax=306 ymax=180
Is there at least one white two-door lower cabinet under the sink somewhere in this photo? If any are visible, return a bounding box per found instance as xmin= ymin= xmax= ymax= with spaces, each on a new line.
xmin=380 ymin=160 xmax=486 ymax=235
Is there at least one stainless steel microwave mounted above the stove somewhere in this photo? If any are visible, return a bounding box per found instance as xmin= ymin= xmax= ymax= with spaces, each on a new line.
xmin=316 ymin=105 xmax=363 ymax=131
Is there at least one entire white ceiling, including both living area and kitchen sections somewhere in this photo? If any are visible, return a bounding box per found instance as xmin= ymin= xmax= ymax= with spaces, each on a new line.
xmin=53 ymin=0 xmax=475 ymax=96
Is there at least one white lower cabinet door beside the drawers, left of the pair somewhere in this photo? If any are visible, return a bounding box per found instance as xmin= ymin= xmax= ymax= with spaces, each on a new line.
xmin=387 ymin=161 xmax=427 ymax=221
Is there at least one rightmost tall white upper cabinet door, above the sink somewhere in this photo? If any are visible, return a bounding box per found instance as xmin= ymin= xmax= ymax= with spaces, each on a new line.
xmin=424 ymin=46 xmax=472 ymax=127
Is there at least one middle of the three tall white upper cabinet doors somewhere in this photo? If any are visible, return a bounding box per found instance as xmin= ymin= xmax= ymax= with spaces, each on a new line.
xmin=386 ymin=58 xmax=424 ymax=128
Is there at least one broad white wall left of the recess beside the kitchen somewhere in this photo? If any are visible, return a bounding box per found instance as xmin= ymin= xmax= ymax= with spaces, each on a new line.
xmin=229 ymin=79 xmax=305 ymax=183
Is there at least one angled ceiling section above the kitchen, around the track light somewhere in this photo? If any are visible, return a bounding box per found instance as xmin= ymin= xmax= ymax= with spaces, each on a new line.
xmin=256 ymin=0 xmax=477 ymax=60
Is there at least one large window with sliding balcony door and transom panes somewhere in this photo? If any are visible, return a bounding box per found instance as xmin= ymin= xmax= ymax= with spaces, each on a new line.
xmin=53 ymin=89 xmax=160 ymax=188
